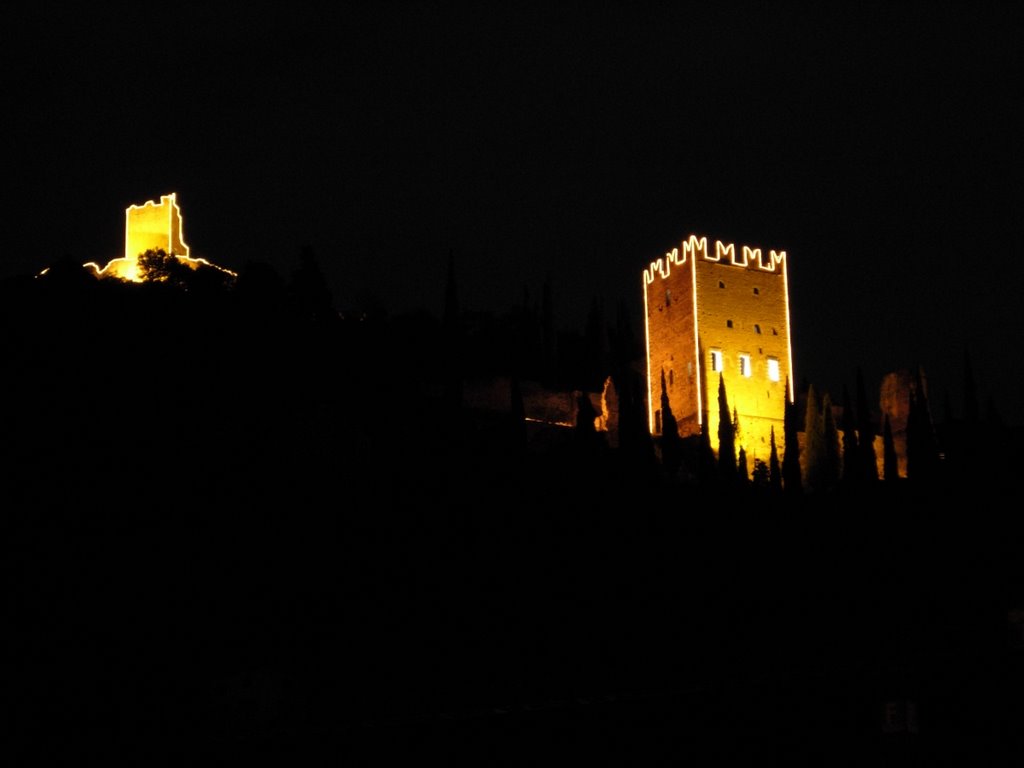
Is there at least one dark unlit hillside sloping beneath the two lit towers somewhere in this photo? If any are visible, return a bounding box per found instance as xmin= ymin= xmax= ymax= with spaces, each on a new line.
xmin=0 ymin=256 xmax=1021 ymax=765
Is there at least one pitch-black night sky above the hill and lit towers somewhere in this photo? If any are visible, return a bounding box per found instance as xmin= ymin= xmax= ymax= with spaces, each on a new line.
xmin=0 ymin=2 xmax=1024 ymax=423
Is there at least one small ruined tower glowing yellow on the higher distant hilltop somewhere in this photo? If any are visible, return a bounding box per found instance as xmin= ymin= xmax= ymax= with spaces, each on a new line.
xmin=85 ymin=193 xmax=238 ymax=283
